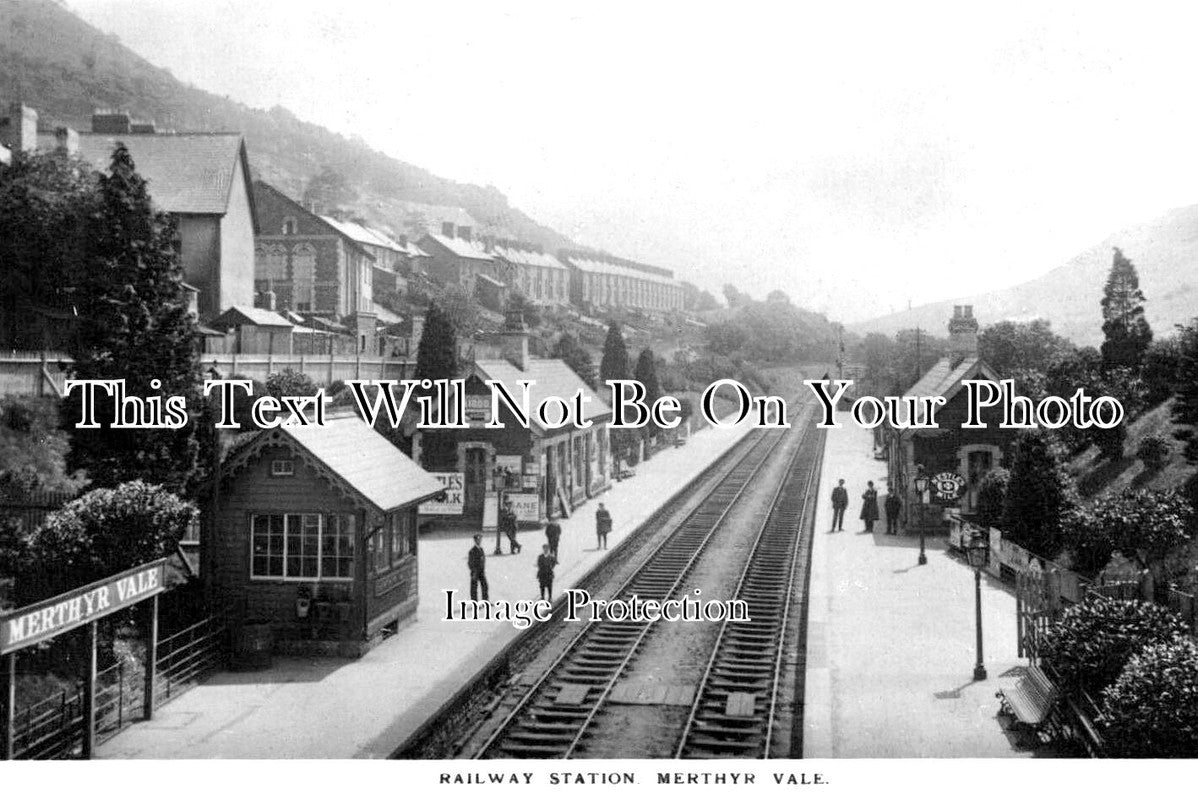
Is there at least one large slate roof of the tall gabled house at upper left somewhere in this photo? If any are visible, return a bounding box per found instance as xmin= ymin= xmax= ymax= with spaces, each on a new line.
xmin=79 ymin=133 xmax=254 ymax=214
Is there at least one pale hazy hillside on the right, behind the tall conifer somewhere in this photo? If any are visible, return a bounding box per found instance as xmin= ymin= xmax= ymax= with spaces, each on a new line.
xmin=848 ymin=206 xmax=1198 ymax=345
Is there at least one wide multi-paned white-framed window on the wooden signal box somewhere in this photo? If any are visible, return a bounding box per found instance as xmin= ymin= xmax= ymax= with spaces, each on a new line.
xmin=250 ymin=514 xmax=355 ymax=581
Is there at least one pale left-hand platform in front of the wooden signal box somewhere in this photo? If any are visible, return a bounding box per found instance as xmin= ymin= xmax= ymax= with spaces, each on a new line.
xmin=97 ymin=424 xmax=751 ymax=759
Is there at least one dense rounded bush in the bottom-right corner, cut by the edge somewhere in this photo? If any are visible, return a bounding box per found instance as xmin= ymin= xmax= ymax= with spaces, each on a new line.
xmin=1097 ymin=638 xmax=1198 ymax=758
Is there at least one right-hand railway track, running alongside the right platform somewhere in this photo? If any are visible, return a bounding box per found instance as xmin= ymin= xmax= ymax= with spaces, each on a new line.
xmin=674 ymin=423 xmax=823 ymax=758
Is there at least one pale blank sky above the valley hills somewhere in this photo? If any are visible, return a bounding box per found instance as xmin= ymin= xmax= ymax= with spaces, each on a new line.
xmin=67 ymin=0 xmax=1198 ymax=322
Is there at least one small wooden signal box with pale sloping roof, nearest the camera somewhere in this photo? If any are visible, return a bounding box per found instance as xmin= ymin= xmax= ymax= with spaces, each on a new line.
xmin=208 ymin=414 xmax=443 ymax=656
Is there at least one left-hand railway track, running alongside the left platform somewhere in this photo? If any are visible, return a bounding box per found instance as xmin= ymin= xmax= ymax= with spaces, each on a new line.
xmin=474 ymin=421 xmax=788 ymax=758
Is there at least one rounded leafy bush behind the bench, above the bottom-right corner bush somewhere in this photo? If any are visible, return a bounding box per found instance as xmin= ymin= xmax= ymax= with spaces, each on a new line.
xmin=1042 ymin=594 xmax=1185 ymax=695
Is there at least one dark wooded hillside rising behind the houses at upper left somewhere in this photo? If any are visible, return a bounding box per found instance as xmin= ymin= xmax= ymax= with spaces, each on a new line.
xmin=0 ymin=0 xmax=576 ymax=249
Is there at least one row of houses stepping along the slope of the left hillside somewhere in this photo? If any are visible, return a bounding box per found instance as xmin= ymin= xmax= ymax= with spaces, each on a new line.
xmin=0 ymin=103 xmax=685 ymax=356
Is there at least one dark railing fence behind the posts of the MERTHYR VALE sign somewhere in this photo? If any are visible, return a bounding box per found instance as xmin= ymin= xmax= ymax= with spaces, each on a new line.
xmin=6 ymin=608 xmax=229 ymax=759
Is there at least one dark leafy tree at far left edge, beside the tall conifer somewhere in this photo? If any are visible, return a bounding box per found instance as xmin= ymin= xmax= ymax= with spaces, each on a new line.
xmin=0 ymin=152 xmax=99 ymax=350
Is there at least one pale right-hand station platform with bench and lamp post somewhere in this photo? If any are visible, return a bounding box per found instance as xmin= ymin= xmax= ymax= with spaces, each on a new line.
xmin=803 ymin=413 xmax=1031 ymax=758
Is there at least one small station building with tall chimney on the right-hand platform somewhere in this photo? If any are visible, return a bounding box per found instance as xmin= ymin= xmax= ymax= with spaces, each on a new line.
xmin=883 ymin=305 xmax=1017 ymax=533
